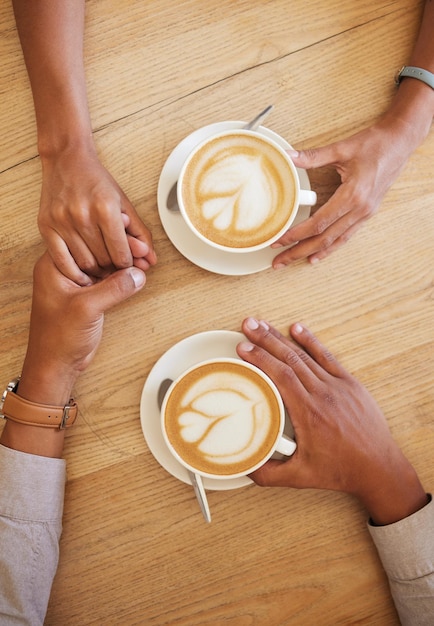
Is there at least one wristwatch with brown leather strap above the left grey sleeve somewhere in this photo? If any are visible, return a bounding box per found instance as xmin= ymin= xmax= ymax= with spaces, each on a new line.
xmin=0 ymin=378 xmax=78 ymax=430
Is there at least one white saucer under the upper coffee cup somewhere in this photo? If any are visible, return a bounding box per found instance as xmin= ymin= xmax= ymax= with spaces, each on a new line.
xmin=157 ymin=122 xmax=311 ymax=276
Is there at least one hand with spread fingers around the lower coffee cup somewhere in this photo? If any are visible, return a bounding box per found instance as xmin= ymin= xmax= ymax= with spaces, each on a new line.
xmin=237 ymin=318 xmax=426 ymax=524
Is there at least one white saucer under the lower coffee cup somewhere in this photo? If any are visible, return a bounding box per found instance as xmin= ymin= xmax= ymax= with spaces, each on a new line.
xmin=140 ymin=330 xmax=252 ymax=491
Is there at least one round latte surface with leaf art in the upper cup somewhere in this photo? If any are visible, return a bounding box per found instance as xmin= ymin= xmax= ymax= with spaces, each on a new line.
xmin=182 ymin=133 xmax=296 ymax=248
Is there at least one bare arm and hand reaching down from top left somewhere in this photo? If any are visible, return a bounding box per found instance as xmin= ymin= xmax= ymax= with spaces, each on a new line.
xmin=13 ymin=0 xmax=156 ymax=285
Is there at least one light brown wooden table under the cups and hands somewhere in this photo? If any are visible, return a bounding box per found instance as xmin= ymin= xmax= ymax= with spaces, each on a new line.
xmin=0 ymin=0 xmax=434 ymax=626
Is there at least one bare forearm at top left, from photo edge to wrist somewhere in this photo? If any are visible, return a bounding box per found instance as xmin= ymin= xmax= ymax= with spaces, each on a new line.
xmin=13 ymin=0 xmax=93 ymax=156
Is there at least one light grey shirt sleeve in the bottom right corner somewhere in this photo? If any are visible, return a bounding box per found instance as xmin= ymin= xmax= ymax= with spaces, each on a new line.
xmin=368 ymin=492 xmax=434 ymax=626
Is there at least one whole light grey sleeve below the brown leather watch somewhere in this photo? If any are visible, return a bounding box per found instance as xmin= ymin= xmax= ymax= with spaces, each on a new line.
xmin=0 ymin=445 xmax=66 ymax=626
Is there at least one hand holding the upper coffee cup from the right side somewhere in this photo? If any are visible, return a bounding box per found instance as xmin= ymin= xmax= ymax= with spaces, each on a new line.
xmin=272 ymin=115 xmax=415 ymax=269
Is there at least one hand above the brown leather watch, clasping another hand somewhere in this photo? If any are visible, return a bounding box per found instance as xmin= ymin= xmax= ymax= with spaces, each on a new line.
xmin=20 ymin=252 xmax=146 ymax=404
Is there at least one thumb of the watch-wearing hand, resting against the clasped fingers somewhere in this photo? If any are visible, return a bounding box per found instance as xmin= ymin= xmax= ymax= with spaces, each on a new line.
xmin=87 ymin=266 xmax=146 ymax=313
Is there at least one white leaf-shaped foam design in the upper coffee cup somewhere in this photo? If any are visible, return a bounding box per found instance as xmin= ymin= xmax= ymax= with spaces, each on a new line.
xmin=200 ymin=153 xmax=276 ymax=231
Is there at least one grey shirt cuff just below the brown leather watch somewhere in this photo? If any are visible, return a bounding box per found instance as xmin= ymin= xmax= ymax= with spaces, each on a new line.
xmin=0 ymin=445 xmax=66 ymax=522
